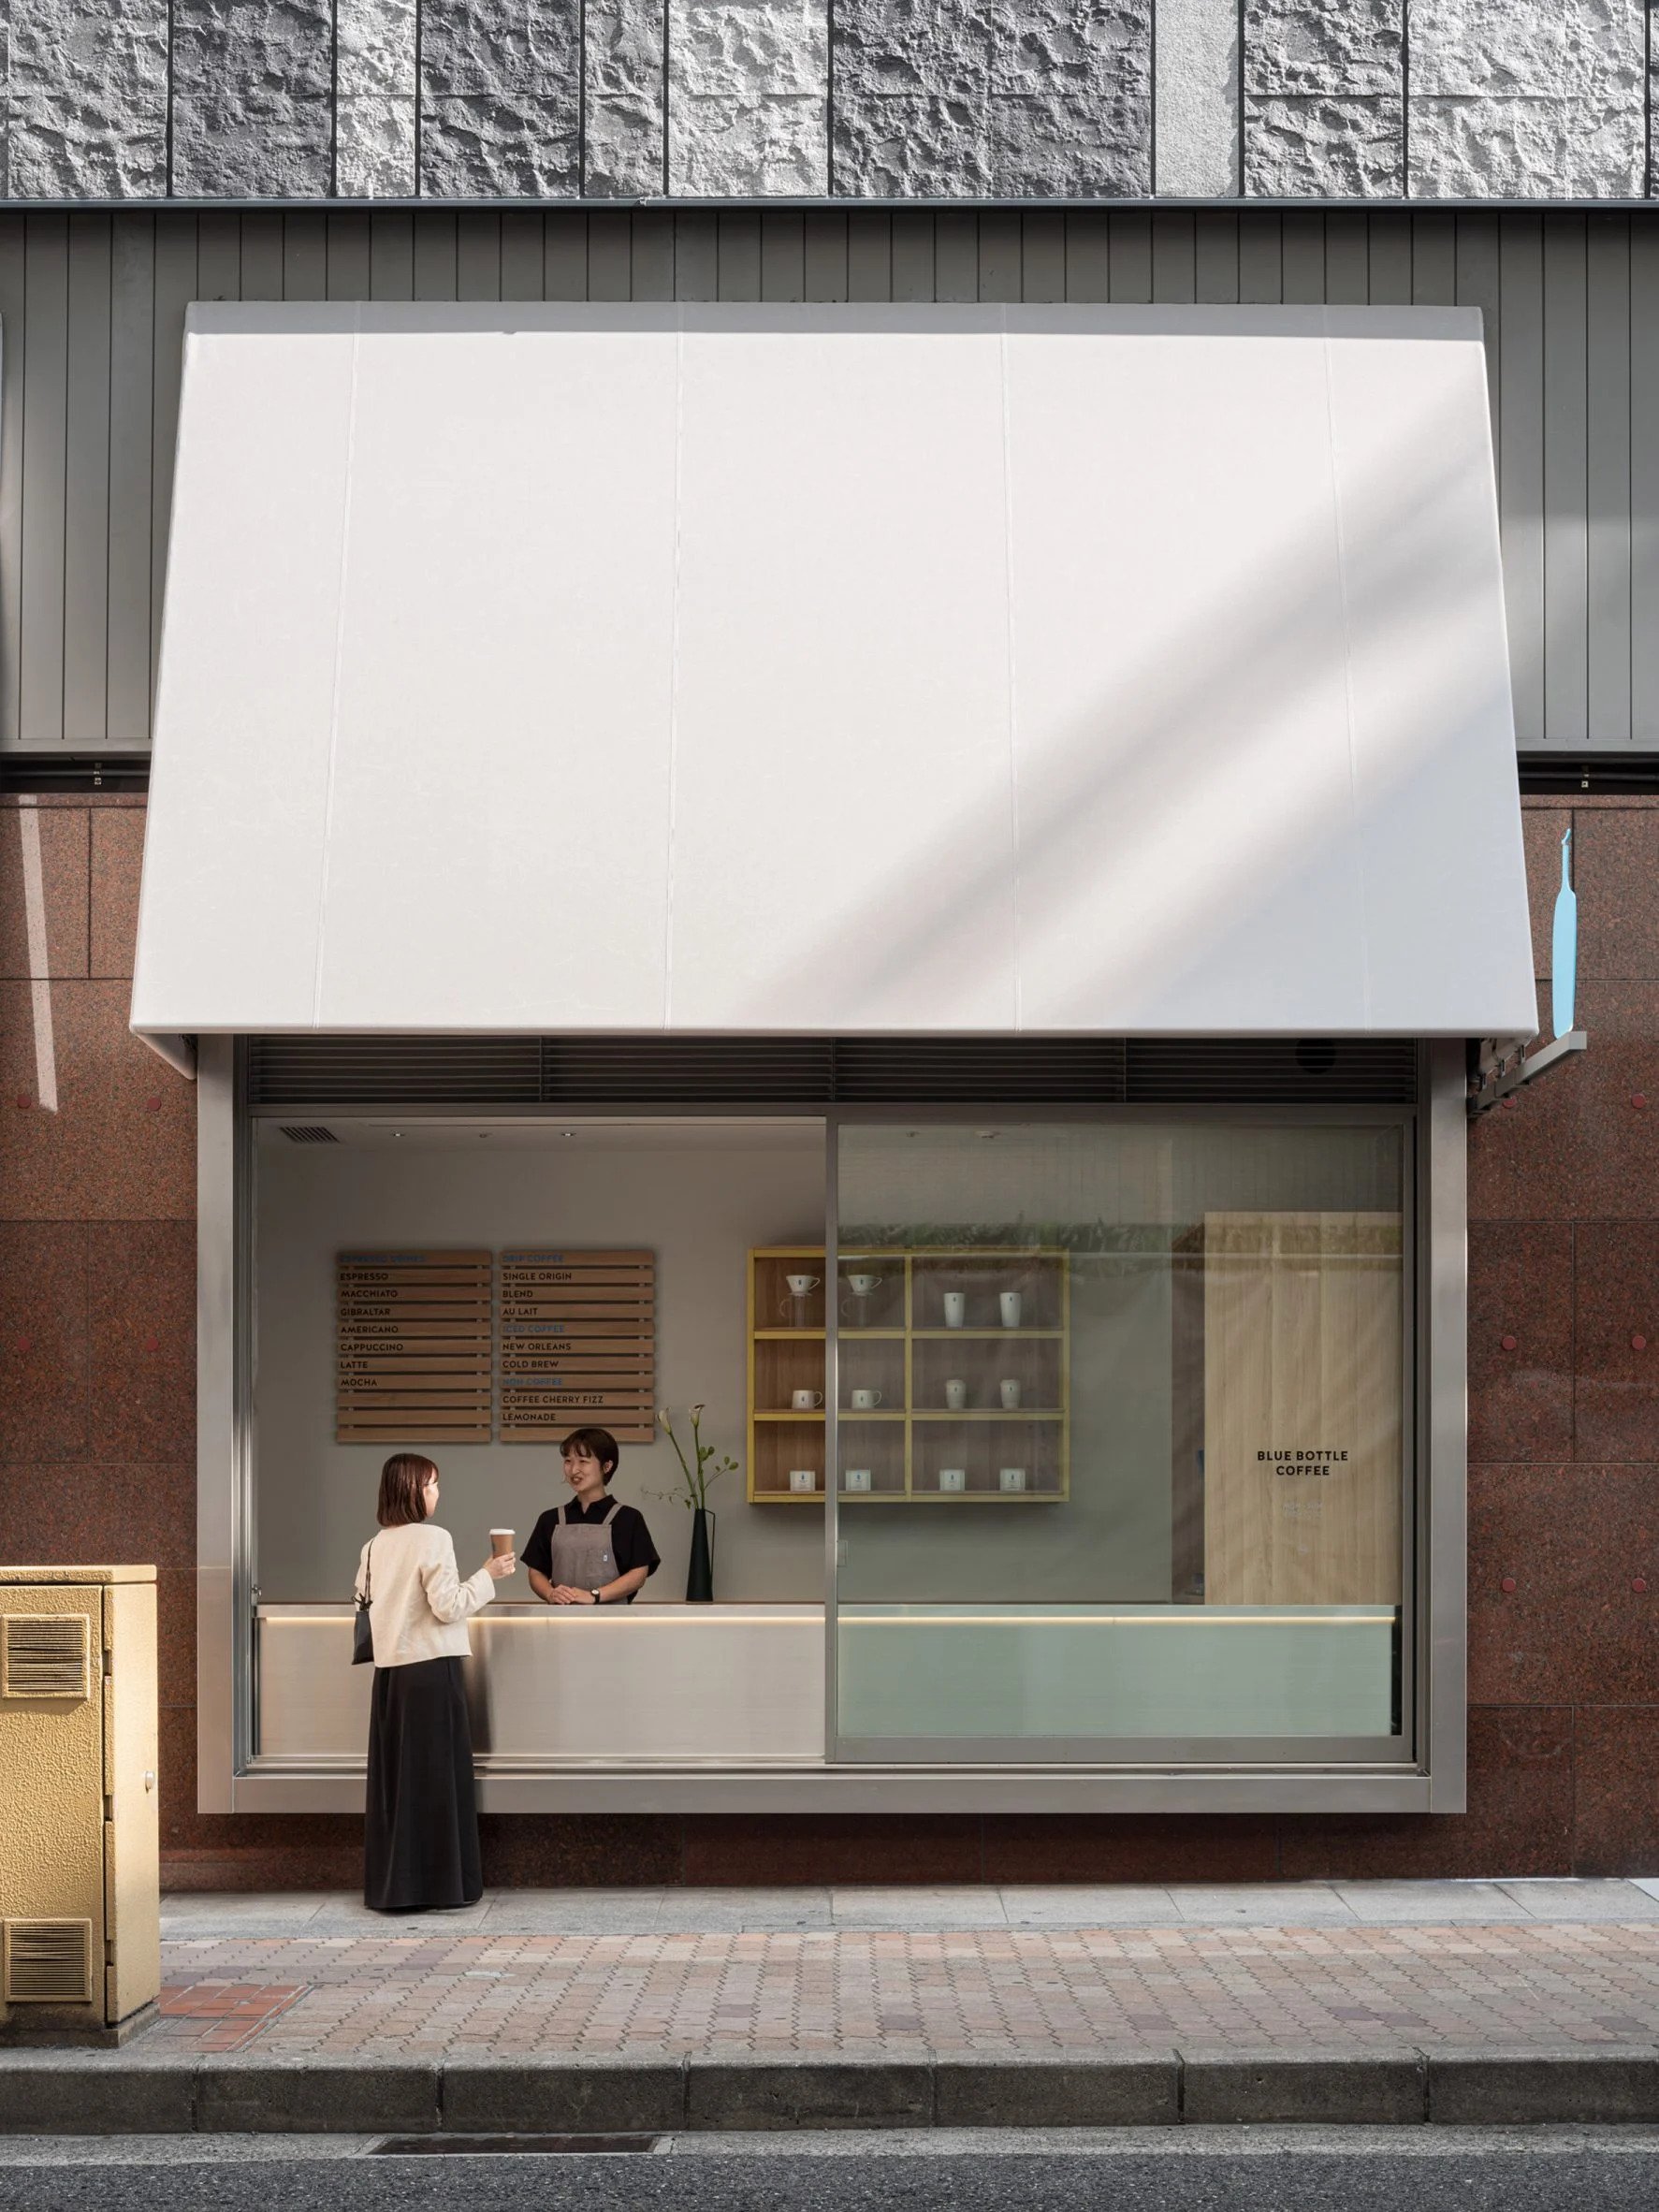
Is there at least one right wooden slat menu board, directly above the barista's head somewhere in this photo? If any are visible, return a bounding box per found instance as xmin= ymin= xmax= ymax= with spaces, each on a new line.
xmin=500 ymin=1252 xmax=657 ymax=1445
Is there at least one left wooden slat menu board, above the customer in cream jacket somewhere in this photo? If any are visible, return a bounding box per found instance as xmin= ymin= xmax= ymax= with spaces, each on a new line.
xmin=334 ymin=1252 xmax=493 ymax=1451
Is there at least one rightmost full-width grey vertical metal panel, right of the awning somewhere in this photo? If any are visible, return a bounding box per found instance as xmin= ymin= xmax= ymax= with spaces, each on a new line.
xmin=1584 ymin=214 xmax=1659 ymax=746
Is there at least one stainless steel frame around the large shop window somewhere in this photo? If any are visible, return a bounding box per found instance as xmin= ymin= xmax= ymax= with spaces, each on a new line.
xmin=196 ymin=1038 xmax=1466 ymax=1816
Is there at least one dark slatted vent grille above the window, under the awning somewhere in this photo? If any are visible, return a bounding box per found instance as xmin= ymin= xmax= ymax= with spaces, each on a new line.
xmin=248 ymin=1035 xmax=1418 ymax=1106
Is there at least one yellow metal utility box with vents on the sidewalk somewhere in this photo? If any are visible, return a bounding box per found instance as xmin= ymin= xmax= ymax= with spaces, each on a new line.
xmin=0 ymin=1566 xmax=162 ymax=2042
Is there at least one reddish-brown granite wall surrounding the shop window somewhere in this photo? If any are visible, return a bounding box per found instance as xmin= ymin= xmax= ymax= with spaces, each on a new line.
xmin=0 ymin=796 xmax=1659 ymax=1889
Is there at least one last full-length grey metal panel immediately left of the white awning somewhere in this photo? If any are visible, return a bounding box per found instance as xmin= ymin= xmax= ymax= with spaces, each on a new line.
xmin=106 ymin=212 xmax=154 ymax=752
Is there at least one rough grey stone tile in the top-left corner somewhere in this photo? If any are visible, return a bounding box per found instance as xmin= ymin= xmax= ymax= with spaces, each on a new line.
xmin=0 ymin=0 xmax=168 ymax=199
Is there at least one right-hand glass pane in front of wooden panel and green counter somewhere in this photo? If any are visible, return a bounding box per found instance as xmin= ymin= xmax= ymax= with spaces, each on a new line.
xmin=837 ymin=1122 xmax=1404 ymax=1758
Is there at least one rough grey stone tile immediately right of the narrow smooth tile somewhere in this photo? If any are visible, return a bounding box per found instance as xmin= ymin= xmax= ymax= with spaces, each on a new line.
xmin=1244 ymin=0 xmax=1406 ymax=199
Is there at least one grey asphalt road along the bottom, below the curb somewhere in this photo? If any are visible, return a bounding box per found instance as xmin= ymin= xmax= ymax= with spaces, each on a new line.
xmin=0 ymin=2131 xmax=1659 ymax=2212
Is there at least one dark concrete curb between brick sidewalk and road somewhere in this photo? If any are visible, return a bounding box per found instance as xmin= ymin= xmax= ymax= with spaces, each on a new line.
xmin=0 ymin=2044 xmax=1659 ymax=2134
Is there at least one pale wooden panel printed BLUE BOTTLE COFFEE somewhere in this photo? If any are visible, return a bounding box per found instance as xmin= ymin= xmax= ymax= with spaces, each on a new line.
xmin=1203 ymin=1212 xmax=1404 ymax=1606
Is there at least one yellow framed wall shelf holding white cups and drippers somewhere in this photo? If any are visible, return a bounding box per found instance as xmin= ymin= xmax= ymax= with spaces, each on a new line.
xmin=748 ymin=1245 xmax=1070 ymax=1506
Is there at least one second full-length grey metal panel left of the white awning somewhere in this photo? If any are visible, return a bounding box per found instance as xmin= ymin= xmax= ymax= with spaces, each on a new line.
xmin=65 ymin=214 xmax=110 ymax=752
